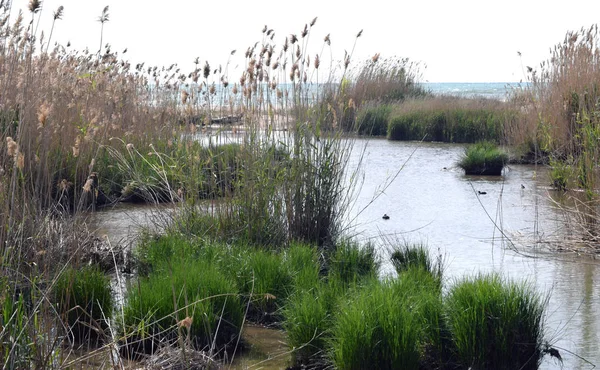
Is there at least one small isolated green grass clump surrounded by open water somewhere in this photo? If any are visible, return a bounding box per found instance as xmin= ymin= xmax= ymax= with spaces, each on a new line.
xmin=458 ymin=141 xmax=508 ymax=176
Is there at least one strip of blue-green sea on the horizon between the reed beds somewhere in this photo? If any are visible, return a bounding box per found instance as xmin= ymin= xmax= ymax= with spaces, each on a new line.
xmin=421 ymin=82 xmax=527 ymax=100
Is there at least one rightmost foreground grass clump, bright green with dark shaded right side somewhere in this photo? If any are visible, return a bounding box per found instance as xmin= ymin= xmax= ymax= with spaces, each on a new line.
xmin=445 ymin=275 xmax=545 ymax=369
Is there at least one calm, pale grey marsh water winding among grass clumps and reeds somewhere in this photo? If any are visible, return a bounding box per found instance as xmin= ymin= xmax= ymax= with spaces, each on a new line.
xmin=93 ymin=139 xmax=600 ymax=369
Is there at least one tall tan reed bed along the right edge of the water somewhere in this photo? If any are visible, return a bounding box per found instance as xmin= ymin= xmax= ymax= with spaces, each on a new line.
xmin=508 ymin=25 xmax=600 ymax=197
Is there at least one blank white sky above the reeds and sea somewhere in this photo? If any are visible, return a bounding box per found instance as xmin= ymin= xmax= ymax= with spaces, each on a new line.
xmin=12 ymin=0 xmax=600 ymax=82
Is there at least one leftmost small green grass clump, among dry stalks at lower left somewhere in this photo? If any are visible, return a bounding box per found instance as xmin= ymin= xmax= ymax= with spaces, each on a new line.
xmin=54 ymin=266 xmax=114 ymax=342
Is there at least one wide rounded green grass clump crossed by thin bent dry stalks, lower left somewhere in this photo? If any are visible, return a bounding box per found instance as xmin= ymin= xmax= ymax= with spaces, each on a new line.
xmin=123 ymin=260 xmax=244 ymax=353
